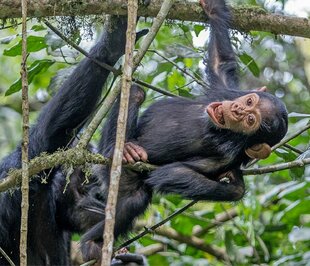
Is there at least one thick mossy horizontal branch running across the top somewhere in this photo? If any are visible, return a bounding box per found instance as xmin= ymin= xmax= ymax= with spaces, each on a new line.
xmin=0 ymin=0 xmax=310 ymax=38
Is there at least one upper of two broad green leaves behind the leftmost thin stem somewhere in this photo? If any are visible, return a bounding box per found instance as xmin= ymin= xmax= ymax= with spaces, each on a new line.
xmin=3 ymin=36 xmax=47 ymax=56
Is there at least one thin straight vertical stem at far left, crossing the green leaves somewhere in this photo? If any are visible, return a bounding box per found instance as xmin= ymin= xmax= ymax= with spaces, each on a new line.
xmin=19 ymin=0 xmax=29 ymax=265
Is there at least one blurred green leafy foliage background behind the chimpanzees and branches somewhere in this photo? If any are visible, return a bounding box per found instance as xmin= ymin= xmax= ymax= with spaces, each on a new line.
xmin=0 ymin=1 xmax=310 ymax=265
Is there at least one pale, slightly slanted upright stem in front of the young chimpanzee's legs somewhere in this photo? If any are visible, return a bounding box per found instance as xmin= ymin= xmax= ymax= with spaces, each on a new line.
xmin=101 ymin=0 xmax=138 ymax=266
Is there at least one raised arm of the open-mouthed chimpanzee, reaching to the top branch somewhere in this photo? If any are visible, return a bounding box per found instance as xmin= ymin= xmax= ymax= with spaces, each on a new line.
xmin=200 ymin=0 xmax=238 ymax=89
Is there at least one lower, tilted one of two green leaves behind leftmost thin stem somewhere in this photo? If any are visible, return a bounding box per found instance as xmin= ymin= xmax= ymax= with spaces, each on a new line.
xmin=5 ymin=59 xmax=55 ymax=96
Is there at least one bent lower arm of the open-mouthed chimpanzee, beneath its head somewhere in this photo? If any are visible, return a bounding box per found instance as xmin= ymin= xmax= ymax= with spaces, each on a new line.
xmin=145 ymin=159 xmax=245 ymax=201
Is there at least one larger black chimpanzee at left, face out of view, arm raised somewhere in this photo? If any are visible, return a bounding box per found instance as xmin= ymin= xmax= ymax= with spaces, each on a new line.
xmin=0 ymin=17 xmax=127 ymax=265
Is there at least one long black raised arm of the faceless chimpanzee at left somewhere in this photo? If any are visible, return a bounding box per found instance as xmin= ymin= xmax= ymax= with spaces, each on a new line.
xmin=0 ymin=18 xmax=127 ymax=177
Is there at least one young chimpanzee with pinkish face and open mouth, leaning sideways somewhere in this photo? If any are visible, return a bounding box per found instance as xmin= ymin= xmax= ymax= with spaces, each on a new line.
xmin=81 ymin=0 xmax=288 ymax=259
